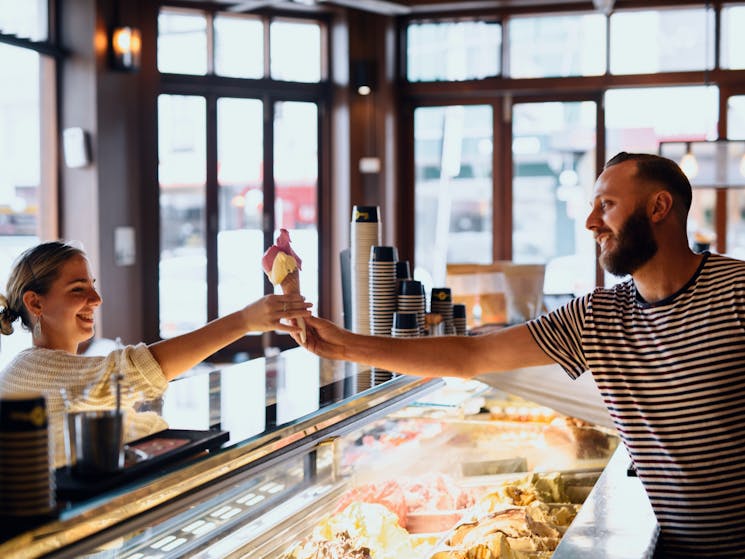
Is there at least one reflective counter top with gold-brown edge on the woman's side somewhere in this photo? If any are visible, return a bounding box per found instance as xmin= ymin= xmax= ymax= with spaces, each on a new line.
xmin=0 ymin=349 xmax=441 ymax=559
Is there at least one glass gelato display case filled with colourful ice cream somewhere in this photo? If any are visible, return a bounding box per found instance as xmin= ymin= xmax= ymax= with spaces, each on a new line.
xmin=0 ymin=349 xmax=654 ymax=559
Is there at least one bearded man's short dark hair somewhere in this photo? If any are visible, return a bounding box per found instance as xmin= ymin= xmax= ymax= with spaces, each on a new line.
xmin=605 ymin=151 xmax=693 ymax=222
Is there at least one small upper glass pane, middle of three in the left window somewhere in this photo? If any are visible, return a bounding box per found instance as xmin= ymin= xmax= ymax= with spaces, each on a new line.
xmin=215 ymin=15 xmax=264 ymax=79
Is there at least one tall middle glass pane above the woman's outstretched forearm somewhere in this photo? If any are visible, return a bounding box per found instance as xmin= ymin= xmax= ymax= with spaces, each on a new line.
xmin=217 ymin=99 xmax=264 ymax=322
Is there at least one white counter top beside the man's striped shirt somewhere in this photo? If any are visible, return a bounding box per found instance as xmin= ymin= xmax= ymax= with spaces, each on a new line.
xmin=553 ymin=445 xmax=659 ymax=559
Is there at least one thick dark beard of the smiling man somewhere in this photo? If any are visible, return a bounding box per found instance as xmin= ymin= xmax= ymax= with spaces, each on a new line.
xmin=600 ymin=206 xmax=658 ymax=277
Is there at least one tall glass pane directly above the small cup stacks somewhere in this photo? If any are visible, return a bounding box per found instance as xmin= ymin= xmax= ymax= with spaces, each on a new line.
xmin=414 ymin=105 xmax=494 ymax=287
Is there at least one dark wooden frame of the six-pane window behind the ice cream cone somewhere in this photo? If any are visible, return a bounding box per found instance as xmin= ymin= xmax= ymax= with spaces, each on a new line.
xmin=151 ymin=2 xmax=332 ymax=362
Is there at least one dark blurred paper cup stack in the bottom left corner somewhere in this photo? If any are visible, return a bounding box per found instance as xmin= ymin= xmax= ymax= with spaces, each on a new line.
xmin=0 ymin=394 xmax=56 ymax=532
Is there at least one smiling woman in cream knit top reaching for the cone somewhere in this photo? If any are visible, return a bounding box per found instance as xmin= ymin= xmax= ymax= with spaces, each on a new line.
xmin=0 ymin=241 xmax=311 ymax=466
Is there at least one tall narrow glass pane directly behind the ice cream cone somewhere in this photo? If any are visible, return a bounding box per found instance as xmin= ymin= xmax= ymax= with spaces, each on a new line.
xmin=274 ymin=102 xmax=318 ymax=310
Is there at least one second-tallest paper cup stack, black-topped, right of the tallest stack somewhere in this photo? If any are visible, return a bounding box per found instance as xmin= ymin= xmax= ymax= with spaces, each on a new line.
xmin=369 ymin=246 xmax=398 ymax=336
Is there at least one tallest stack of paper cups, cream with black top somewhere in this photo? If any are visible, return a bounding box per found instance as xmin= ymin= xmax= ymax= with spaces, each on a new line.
xmin=349 ymin=206 xmax=382 ymax=334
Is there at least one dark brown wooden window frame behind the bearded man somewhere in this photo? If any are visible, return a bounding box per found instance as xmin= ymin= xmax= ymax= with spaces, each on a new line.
xmin=397 ymin=0 xmax=745 ymax=286
